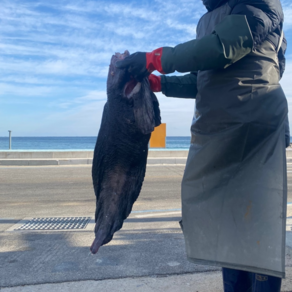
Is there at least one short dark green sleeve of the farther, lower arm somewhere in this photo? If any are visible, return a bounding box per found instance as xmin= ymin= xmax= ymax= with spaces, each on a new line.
xmin=161 ymin=72 xmax=198 ymax=98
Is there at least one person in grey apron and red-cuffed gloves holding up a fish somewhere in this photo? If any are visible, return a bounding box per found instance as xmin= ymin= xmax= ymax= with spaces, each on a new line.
xmin=116 ymin=0 xmax=290 ymax=292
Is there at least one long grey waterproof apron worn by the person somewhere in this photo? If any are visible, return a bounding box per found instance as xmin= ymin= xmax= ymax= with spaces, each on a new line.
xmin=182 ymin=4 xmax=288 ymax=277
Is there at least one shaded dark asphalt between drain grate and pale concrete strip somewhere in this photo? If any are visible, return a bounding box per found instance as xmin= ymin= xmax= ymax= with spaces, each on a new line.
xmin=0 ymin=224 xmax=216 ymax=287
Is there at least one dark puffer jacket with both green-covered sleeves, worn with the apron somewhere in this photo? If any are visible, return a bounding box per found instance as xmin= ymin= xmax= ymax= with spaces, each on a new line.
xmin=161 ymin=0 xmax=287 ymax=98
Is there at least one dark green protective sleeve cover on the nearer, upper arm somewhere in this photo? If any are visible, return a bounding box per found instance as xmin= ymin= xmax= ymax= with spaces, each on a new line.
xmin=161 ymin=15 xmax=253 ymax=74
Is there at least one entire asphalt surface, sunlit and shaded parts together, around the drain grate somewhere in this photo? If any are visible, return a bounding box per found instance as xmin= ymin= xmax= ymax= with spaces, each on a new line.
xmin=0 ymin=164 xmax=292 ymax=287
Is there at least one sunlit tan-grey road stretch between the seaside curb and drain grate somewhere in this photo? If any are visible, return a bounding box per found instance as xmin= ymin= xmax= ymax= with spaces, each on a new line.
xmin=0 ymin=164 xmax=292 ymax=224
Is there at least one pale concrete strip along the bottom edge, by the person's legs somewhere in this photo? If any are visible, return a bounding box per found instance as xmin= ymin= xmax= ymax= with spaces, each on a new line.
xmin=0 ymin=268 xmax=292 ymax=292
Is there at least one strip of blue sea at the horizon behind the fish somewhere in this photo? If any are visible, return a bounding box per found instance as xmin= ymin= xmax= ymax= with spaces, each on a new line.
xmin=0 ymin=136 xmax=191 ymax=151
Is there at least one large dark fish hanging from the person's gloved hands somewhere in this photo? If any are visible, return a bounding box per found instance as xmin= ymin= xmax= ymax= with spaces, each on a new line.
xmin=90 ymin=51 xmax=161 ymax=254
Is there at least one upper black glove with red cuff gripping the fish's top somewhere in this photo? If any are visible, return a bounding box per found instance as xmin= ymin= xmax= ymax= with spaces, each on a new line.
xmin=116 ymin=48 xmax=164 ymax=79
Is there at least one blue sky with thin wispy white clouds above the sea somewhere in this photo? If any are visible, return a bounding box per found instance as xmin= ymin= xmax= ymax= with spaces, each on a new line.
xmin=0 ymin=0 xmax=292 ymax=136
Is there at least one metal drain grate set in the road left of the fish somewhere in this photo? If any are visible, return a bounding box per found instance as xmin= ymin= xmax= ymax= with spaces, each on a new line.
xmin=14 ymin=217 xmax=91 ymax=230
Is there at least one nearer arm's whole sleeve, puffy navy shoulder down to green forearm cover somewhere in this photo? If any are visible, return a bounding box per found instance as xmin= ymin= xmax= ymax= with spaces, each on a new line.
xmin=161 ymin=0 xmax=283 ymax=74
